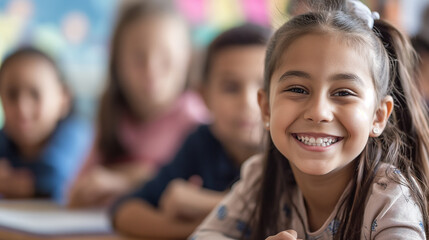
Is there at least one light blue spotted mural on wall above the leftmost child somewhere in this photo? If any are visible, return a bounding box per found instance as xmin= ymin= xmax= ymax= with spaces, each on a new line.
xmin=0 ymin=0 xmax=118 ymax=120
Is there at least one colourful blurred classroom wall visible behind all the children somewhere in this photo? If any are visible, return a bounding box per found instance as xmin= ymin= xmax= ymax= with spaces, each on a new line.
xmin=0 ymin=0 xmax=429 ymax=125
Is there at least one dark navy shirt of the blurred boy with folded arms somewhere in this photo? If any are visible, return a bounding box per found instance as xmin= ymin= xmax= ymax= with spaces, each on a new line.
xmin=125 ymin=125 xmax=240 ymax=207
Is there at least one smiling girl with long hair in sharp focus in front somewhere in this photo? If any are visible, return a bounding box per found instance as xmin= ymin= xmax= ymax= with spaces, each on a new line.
xmin=193 ymin=0 xmax=429 ymax=240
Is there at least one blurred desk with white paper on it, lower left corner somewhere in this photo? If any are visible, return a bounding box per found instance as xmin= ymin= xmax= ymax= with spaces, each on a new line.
xmin=0 ymin=200 xmax=148 ymax=240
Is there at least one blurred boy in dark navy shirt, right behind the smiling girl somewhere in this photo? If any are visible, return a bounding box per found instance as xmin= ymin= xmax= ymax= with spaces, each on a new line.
xmin=112 ymin=24 xmax=270 ymax=239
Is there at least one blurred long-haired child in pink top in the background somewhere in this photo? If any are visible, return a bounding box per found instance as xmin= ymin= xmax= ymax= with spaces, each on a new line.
xmin=69 ymin=0 xmax=207 ymax=207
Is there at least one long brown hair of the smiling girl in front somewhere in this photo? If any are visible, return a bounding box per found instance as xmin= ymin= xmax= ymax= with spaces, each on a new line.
xmin=249 ymin=1 xmax=429 ymax=240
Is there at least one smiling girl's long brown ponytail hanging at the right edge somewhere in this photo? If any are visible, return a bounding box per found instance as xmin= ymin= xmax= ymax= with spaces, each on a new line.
xmin=374 ymin=20 xmax=429 ymax=236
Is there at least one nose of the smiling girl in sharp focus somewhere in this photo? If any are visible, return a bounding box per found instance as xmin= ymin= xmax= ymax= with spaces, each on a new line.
xmin=304 ymin=95 xmax=334 ymax=123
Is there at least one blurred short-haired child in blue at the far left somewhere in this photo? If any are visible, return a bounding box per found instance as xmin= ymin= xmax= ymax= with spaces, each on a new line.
xmin=0 ymin=48 xmax=92 ymax=202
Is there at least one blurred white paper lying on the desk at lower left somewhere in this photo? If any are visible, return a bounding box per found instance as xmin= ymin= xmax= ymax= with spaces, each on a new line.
xmin=0 ymin=200 xmax=111 ymax=235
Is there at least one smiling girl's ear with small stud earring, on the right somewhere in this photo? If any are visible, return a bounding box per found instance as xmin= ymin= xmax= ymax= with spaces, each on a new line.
xmin=369 ymin=96 xmax=393 ymax=137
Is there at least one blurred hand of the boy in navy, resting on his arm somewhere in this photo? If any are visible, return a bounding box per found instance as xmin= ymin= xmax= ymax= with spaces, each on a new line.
xmin=160 ymin=176 xmax=205 ymax=220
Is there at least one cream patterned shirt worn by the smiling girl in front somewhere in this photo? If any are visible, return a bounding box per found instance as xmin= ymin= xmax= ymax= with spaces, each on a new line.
xmin=190 ymin=155 xmax=426 ymax=240
